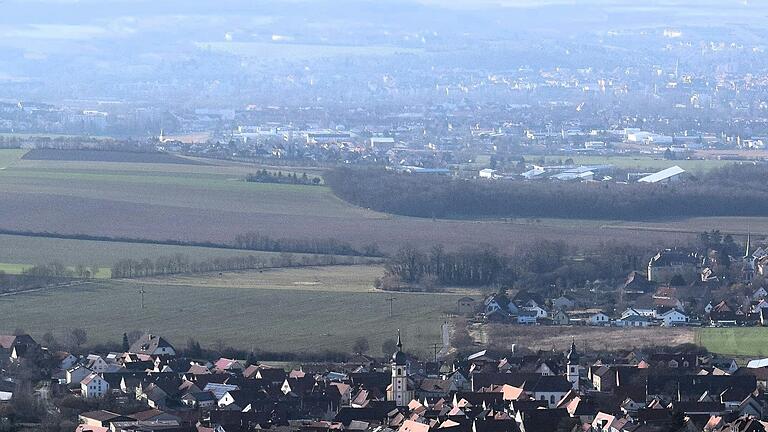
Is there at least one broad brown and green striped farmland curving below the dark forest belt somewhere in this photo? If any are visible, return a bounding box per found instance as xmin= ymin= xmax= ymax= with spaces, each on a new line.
xmin=0 ymin=154 xmax=768 ymax=252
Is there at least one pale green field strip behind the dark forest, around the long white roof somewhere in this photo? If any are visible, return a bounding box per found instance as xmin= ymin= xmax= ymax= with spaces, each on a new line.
xmin=524 ymin=155 xmax=733 ymax=174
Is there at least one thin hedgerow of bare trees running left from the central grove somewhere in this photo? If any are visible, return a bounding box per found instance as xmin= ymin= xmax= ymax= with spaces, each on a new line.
xmin=112 ymin=252 xmax=370 ymax=278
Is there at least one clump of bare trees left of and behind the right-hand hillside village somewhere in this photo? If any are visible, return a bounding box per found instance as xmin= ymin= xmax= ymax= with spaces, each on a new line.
xmin=377 ymin=241 xmax=654 ymax=291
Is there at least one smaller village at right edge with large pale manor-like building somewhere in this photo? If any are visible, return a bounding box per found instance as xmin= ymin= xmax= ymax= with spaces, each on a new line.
xmin=456 ymin=233 xmax=768 ymax=327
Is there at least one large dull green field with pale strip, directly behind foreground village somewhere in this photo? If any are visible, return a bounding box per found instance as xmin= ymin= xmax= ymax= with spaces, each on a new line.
xmin=0 ymin=266 xmax=460 ymax=355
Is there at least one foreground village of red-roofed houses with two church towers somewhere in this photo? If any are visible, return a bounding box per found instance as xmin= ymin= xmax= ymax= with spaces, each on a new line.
xmin=0 ymin=324 xmax=768 ymax=432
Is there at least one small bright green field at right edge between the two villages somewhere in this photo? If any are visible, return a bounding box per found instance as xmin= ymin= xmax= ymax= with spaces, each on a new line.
xmin=696 ymin=327 xmax=768 ymax=357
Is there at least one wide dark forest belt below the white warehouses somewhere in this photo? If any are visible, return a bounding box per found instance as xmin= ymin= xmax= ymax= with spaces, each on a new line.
xmin=324 ymin=164 xmax=768 ymax=220
